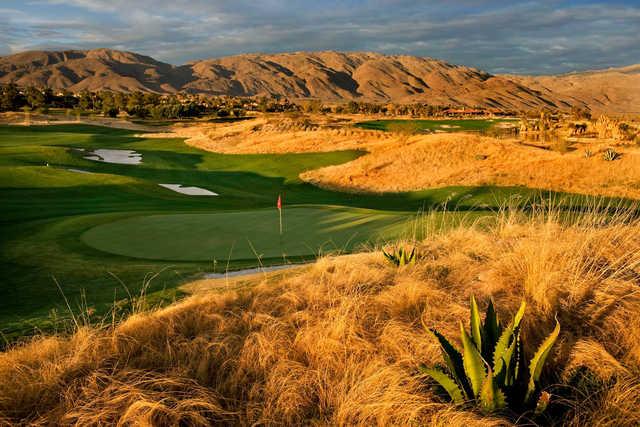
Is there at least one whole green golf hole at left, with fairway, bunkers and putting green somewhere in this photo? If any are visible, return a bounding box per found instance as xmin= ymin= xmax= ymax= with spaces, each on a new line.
xmin=0 ymin=124 xmax=600 ymax=340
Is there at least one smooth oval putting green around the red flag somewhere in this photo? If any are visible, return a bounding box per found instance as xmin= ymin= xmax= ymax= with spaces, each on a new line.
xmin=82 ymin=206 xmax=413 ymax=261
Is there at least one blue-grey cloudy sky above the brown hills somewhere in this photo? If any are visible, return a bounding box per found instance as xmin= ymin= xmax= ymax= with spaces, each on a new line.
xmin=0 ymin=0 xmax=640 ymax=74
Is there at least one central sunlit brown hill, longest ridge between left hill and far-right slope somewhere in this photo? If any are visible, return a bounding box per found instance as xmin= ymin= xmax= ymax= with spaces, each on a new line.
xmin=186 ymin=52 xmax=553 ymax=108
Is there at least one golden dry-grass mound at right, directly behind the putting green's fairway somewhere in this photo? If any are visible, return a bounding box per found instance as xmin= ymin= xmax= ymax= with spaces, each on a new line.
xmin=301 ymin=134 xmax=640 ymax=199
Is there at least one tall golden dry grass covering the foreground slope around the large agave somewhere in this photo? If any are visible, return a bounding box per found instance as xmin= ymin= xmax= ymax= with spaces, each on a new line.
xmin=0 ymin=209 xmax=640 ymax=426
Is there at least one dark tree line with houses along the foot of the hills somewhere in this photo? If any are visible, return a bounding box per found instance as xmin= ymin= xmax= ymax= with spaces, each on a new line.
xmin=0 ymin=83 xmax=512 ymax=120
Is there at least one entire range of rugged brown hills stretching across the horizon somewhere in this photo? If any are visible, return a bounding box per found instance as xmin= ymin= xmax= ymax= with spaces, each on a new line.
xmin=0 ymin=49 xmax=640 ymax=111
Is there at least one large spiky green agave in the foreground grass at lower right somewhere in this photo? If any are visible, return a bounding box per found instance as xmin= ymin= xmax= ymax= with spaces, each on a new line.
xmin=421 ymin=297 xmax=560 ymax=413
